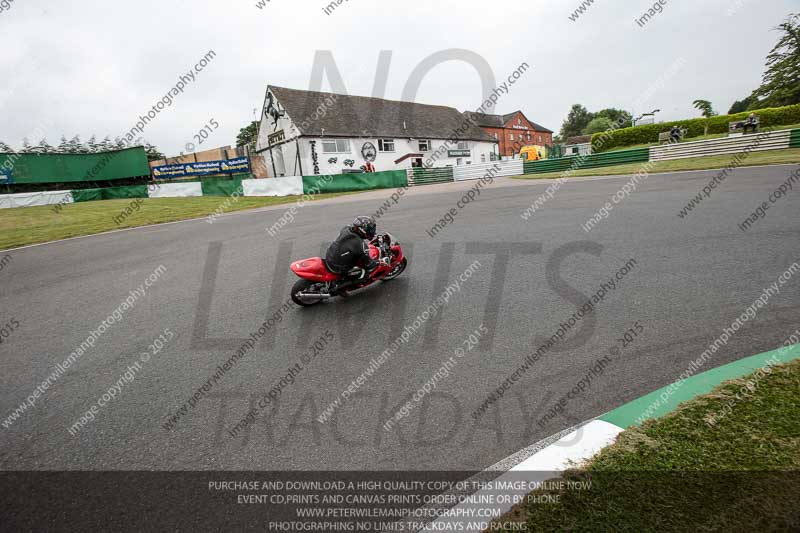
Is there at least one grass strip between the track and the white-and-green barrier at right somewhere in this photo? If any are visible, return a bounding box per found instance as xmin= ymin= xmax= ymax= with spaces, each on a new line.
xmin=515 ymin=148 xmax=800 ymax=180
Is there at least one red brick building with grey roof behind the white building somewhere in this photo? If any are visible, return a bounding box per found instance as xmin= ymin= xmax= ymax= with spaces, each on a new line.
xmin=464 ymin=111 xmax=553 ymax=157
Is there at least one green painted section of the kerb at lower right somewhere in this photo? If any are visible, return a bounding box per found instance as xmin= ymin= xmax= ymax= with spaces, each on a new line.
xmin=598 ymin=344 xmax=800 ymax=428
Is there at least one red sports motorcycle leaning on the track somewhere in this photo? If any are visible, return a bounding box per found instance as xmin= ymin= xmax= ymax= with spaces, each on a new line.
xmin=292 ymin=233 xmax=408 ymax=307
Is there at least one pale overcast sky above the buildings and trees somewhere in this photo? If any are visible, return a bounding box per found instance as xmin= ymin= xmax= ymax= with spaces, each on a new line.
xmin=0 ymin=0 xmax=800 ymax=155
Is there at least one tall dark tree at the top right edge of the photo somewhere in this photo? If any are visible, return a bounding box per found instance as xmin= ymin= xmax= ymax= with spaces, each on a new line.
xmin=749 ymin=13 xmax=800 ymax=109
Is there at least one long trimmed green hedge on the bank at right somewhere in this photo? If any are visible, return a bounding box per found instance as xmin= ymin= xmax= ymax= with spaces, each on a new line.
xmin=592 ymin=104 xmax=800 ymax=153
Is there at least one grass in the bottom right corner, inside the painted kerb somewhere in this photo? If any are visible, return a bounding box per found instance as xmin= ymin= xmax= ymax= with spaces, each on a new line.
xmin=493 ymin=360 xmax=800 ymax=531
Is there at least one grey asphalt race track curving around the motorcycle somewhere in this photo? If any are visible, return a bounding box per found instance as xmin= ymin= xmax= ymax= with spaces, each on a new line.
xmin=0 ymin=165 xmax=800 ymax=470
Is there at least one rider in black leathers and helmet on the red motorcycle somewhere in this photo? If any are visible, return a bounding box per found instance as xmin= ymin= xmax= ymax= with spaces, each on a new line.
xmin=325 ymin=216 xmax=390 ymax=296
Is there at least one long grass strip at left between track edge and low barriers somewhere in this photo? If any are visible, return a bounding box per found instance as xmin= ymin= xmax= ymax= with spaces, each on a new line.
xmin=0 ymin=193 xmax=355 ymax=250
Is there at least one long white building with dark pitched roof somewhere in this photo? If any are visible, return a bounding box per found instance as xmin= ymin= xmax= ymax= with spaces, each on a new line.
xmin=256 ymin=86 xmax=497 ymax=177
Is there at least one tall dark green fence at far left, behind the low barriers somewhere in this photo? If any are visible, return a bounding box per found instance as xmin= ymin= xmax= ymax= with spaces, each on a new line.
xmin=0 ymin=147 xmax=150 ymax=183
